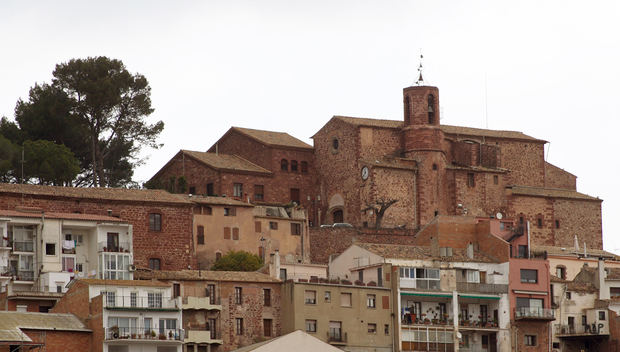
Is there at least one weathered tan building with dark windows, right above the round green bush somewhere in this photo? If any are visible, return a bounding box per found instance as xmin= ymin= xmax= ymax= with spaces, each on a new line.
xmin=189 ymin=196 xmax=310 ymax=269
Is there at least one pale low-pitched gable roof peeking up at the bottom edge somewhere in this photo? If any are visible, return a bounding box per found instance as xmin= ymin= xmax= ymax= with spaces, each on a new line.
xmin=232 ymin=330 xmax=342 ymax=352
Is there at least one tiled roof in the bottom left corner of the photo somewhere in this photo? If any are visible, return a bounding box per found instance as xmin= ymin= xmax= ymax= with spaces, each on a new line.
xmin=0 ymin=311 xmax=91 ymax=342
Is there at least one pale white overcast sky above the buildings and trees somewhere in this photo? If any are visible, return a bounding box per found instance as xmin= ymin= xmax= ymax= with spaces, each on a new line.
xmin=0 ymin=0 xmax=620 ymax=253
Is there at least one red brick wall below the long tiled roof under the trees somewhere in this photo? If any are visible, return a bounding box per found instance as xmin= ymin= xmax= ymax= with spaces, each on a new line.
xmin=0 ymin=193 xmax=195 ymax=270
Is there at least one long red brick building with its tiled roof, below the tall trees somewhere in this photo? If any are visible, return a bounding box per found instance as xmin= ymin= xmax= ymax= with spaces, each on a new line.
xmin=0 ymin=183 xmax=195 ymax=270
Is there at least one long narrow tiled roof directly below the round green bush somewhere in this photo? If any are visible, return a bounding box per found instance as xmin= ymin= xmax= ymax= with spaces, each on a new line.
xmin=134 ymin=270 xmax=281 ymax=283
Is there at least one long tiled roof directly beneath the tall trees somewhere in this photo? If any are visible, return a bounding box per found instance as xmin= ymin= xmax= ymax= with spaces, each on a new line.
xmin=0 ymin=183 xmax=191 ymax=205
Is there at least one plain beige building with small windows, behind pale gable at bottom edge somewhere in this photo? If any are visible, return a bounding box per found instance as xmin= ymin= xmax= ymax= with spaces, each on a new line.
xmin=281 ymin=279 xmax=395 ymax=352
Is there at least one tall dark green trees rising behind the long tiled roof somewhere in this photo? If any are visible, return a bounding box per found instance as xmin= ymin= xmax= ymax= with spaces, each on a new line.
xmin=0 ymin=56 xmax=164 ymax=187
